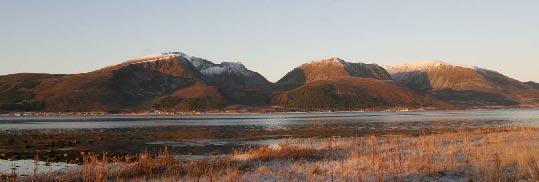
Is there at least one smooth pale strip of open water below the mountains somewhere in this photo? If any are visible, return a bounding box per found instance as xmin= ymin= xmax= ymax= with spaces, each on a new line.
xmin=0 ymin=109 xmax=539 ymax=131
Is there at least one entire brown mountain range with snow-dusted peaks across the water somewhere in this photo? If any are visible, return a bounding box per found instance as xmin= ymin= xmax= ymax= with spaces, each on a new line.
xmin=0 ymin=52 xmax=539 ymax=112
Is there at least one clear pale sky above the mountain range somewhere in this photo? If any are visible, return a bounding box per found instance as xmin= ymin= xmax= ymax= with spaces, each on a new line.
xmin=0 ymin=0 xmax=539 ymax=81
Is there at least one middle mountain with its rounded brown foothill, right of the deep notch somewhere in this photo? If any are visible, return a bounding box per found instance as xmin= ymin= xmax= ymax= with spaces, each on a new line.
xmin=271 ymin=58 xmax=448 ymax=110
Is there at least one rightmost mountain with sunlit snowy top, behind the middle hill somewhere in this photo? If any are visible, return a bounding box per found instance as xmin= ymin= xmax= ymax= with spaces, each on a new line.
xmin=386 ymin=61 xmax=539 ymax=106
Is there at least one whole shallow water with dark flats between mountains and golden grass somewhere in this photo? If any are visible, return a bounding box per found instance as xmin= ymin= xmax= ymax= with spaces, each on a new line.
xmin=0 ymin=109 xmax=539 ymax=159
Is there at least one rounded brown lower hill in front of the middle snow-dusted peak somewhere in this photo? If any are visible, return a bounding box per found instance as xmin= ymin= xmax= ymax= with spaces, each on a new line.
xmin=271 ymin=76 xmax=452 ymax=110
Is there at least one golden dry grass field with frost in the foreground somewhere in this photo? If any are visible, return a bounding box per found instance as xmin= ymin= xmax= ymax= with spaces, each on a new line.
xmin=2 ymin=128 xmax=539 ymax=181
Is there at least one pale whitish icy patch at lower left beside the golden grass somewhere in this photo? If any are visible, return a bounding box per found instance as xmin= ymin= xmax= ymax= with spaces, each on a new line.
xmin=0 ymin=160 xmax=79 ymax=176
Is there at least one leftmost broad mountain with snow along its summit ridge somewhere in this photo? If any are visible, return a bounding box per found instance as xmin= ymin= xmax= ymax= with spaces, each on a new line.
xmin=0 ymin=52 xmax=271 ymax=112
